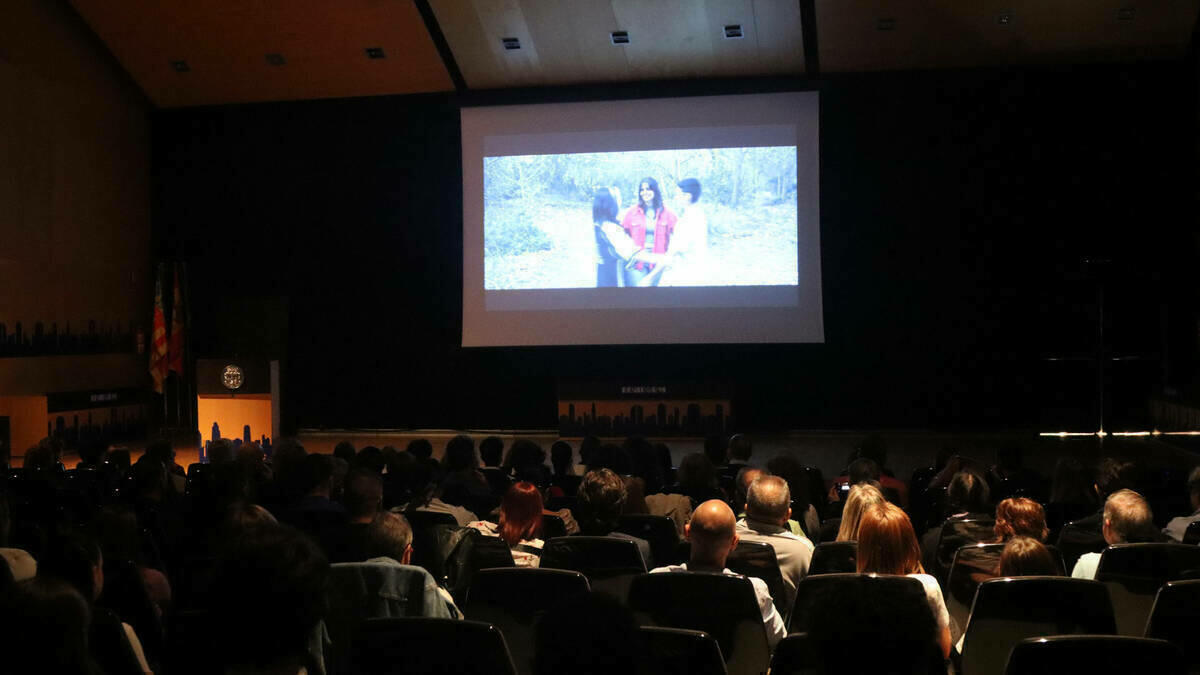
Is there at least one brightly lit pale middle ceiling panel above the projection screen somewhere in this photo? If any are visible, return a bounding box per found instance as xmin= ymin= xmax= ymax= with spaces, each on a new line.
xmin=431 ymin=0 xmax=804 ymax=89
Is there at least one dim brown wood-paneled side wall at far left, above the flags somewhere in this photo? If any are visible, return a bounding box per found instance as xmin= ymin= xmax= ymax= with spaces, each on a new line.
xmin=0 ymin=0 xmax=150 ymax=394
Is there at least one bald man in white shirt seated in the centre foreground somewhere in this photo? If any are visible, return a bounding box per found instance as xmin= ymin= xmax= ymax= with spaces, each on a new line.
xmin=650 ymin=500 xmax=787 ymax=649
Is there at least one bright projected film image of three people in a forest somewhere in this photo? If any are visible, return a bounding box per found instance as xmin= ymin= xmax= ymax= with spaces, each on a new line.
xmin=484 ymin=145 xmax=798 ymax=291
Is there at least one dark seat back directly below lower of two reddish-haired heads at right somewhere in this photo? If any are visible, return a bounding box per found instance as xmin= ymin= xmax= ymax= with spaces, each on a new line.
xmin=961 ymin=577 xmax=1116 ymax=675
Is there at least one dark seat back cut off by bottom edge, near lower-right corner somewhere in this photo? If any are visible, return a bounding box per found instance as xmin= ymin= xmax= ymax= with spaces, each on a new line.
xmin=1004 ymin=635 xmax=1184 ymax=675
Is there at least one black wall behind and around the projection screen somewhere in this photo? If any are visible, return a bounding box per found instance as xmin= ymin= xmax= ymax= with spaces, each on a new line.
xmin=154 ymin=64 xmax=1196 ymax=429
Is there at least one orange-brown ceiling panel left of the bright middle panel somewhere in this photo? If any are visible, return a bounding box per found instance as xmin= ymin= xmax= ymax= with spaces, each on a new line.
xmin=71 ymin=0 xmax=454 ymax=107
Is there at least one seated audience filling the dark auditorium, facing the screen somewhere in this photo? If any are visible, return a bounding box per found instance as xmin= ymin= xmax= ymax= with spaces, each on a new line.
xmin=0 ymin=436 xmax=1200 ymax=675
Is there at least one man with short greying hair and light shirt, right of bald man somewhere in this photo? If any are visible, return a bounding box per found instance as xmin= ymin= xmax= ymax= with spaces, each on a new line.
xmin=737 ymin=476 xmax=812 ymax=608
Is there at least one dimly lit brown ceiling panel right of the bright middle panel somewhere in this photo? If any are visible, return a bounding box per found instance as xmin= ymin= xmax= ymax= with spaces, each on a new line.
xmin=816 ymin=0 xmax=1200 ymax=72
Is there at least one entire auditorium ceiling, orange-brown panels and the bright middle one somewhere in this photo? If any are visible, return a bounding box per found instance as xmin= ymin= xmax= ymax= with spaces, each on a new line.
xmin=70 ymin=0 xmax=1200 ymax=108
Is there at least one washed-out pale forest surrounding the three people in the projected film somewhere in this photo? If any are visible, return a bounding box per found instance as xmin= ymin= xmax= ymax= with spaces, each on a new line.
xmin=484 ymin=145 xmax=798 ymax=289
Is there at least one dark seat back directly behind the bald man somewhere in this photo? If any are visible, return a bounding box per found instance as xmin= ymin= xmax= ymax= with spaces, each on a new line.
xmin=629 ymin=572 xmax=770 ymax=674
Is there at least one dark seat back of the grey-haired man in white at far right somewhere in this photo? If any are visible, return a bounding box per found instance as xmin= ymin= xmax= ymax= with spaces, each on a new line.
xmin=1096 ymin=544 xmax=1200 ymax=637
